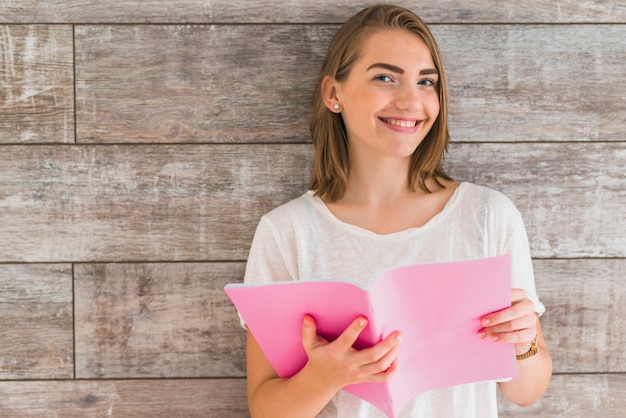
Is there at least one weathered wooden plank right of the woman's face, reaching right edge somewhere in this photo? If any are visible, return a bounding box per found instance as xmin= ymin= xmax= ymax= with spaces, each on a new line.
xmin=433 ymin=25 xmax=626 ymax=142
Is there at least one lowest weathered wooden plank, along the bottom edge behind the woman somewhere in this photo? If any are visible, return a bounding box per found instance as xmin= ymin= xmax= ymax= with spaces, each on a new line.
xmin=0 ymin=374 xmax=626 ymax=418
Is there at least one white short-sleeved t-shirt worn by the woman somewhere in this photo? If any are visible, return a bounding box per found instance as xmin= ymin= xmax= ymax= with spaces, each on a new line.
xmin=245 ymin=183 xmax=545 ymax=418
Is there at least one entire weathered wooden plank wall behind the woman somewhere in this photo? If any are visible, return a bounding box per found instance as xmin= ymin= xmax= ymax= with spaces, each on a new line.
xmin=0 ymin=0 xmax=626 ymax=418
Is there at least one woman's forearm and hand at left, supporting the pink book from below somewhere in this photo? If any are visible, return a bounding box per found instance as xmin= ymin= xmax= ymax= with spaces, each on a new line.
xmin=246 ymin=316 xmax=401 ymax=418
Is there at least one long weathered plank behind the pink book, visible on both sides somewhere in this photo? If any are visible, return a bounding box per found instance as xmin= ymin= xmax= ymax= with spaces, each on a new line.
xmin=70 ymin=259 xmax=626 ymax=378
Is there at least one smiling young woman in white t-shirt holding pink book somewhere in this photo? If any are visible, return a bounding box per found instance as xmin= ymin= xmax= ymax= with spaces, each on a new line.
xmin=245 ymin=5 xmax=552 ymax=418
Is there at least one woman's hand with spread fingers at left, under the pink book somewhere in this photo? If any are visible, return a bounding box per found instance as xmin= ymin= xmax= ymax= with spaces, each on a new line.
xmin=302 ymin=315 xmax=402 ymax=390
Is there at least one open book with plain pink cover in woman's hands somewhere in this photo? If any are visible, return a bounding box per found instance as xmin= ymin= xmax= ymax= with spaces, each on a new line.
xmin=224 ymin=256 xmax=517 ymax=417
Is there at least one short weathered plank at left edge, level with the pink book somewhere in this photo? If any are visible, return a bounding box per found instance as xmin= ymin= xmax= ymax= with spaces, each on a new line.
xmin=0 ymin=264 xmax=74 ymax=378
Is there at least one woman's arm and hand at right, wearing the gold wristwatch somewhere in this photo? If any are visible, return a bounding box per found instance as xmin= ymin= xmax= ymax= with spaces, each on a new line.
xmin=480 ymin=289 xmax=552 ymax=406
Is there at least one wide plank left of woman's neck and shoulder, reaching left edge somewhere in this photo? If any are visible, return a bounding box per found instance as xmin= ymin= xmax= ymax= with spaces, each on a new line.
xmin=0 ymin=145 xmax=310 ymax=262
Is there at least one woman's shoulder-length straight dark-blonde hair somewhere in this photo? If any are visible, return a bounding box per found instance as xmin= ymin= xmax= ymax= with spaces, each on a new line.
xmin=309 ymin=4 xmax=451 ymax=201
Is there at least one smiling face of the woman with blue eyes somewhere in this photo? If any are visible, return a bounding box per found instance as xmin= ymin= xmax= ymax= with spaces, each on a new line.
xmin=335 ymin=30 xmax=439 ymax=162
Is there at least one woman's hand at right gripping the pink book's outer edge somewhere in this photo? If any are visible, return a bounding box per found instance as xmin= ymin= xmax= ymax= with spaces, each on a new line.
xmin=478 ymin=289 xmax=537 ymax=354
